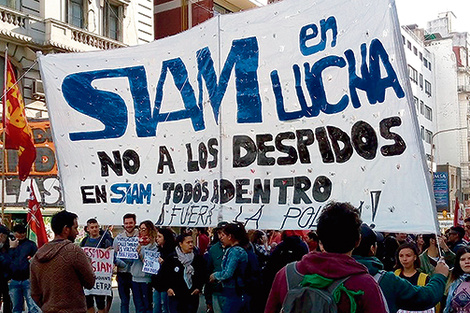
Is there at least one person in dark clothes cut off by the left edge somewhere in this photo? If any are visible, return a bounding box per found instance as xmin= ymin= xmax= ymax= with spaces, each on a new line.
xmin=0 ymin=225 xmax=11 ymax=313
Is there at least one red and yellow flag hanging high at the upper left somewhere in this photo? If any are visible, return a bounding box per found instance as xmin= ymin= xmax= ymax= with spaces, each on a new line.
xmin=3 ymin=60 xmax=36 ymax=181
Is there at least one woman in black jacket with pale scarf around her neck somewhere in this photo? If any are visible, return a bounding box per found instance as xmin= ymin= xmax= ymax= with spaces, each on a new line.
xmin=159 ymin=233 xmax=207 ymax=313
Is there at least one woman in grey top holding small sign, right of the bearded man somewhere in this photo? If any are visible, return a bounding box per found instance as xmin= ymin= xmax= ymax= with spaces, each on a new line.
xmin=130 ymin=220 xmax=158 ymax=313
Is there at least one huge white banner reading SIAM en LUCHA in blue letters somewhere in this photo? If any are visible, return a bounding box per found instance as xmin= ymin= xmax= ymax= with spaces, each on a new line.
xmin=40 ymin=0 xmax=436 ymax=232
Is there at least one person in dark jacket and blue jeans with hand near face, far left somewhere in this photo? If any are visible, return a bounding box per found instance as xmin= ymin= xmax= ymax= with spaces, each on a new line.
xmin=9 ymin=224 xmax=40 ymax=313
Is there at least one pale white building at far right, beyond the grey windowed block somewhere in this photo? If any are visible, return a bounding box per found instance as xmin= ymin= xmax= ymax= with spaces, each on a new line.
xmin=426 ymin=12 xmax=470 ymax=208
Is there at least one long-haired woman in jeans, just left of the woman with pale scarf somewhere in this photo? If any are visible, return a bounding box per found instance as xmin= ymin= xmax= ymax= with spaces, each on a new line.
xmin=152 ymin=228 xmax=176 ymax=313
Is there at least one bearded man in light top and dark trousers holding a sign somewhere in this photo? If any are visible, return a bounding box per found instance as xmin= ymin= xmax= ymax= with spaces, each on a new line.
xmin=113 ymin=213 xmax=139 ymax=313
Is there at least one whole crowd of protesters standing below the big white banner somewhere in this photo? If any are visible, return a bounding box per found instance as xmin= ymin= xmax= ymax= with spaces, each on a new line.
xmin=0 ymin=206 xmax=470 ymax=313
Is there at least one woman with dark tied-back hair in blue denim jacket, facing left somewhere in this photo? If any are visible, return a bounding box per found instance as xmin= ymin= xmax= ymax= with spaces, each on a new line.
xmin=209 ymin=223 xmax=249 ymax=313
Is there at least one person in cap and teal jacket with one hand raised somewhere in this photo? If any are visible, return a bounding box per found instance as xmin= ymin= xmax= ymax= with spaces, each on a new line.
xmin=353 ymin=224 xmax=449 ymax=313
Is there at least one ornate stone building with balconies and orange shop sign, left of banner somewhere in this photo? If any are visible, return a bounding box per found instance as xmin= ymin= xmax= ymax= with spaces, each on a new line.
xmin=0 ymin=0 xmax=154 ymax=224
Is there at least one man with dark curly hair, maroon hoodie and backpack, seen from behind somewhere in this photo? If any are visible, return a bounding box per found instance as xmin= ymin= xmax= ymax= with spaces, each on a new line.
xmin=264 ymin=202 xmax=387 ymax=313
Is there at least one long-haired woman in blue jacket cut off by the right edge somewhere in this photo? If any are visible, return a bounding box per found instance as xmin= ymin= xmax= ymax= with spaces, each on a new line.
xmin=444 ymin=246 xmax=470 ymax=313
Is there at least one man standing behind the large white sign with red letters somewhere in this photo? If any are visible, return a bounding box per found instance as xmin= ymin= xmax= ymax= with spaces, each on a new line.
xmin=80 ymin=218 xmax=113 ymax=313
